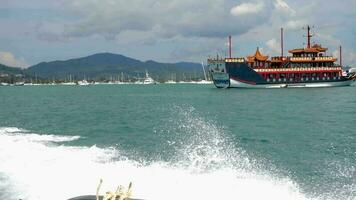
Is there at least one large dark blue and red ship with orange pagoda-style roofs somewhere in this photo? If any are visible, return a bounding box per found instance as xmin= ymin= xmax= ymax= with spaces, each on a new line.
xmin=208 ymin=26 xmax=355 ymax=88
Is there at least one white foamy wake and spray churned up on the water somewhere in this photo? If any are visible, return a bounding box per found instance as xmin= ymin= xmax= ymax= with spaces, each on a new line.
xmin=0 ymin=115 xmax=306 ymax=200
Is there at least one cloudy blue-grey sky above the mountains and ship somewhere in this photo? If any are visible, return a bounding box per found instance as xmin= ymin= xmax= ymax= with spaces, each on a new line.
xmin=0 ymin=0 xmax=356 ymax=67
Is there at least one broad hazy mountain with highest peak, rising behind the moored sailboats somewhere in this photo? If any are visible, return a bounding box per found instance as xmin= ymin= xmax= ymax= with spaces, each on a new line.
xmin=26 ymin=53 xmax=203 ymax=80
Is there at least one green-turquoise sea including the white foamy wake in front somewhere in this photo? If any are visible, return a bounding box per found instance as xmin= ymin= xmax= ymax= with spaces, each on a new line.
xmin=0 ymin=84 xmax=356 ymax=200
